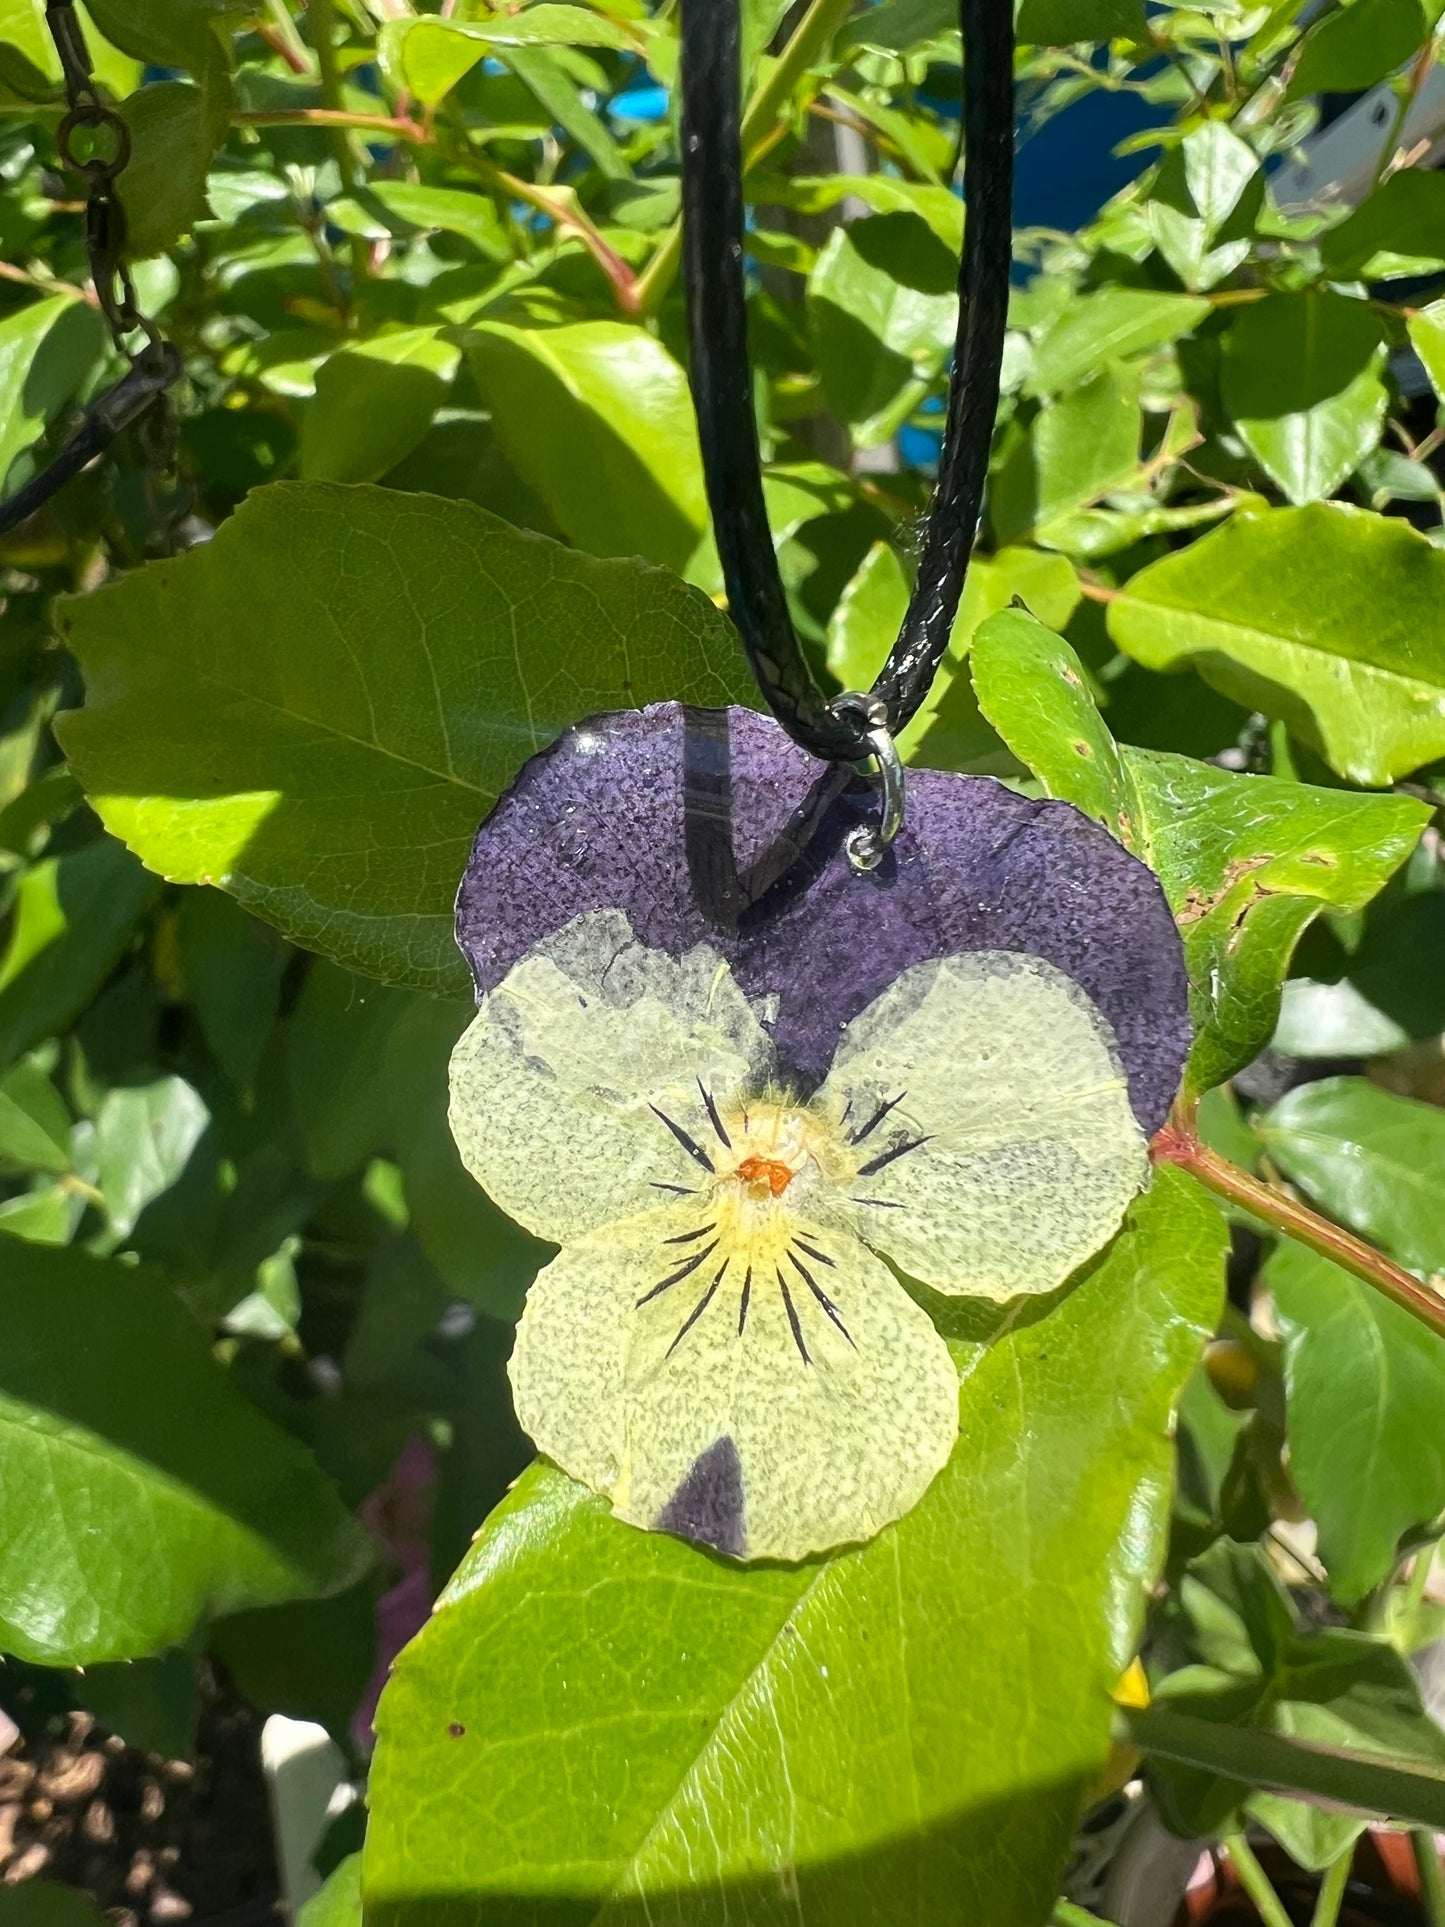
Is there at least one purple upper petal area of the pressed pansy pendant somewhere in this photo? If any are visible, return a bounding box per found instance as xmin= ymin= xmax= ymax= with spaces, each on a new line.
xmin=457 ymin=703 xmax=1189 ymax=1133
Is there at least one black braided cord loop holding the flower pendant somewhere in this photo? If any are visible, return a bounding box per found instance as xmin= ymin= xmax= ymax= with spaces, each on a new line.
xmin=682 ymin=0 xmax=1013 ymax=761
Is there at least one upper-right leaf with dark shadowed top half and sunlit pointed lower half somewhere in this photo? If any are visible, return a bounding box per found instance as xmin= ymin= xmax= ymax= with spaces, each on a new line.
xmin=1222 ymin=290 xmax=1414 ymax=503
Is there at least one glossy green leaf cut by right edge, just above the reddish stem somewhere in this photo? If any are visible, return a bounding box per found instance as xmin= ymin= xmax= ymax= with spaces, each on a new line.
xmin=1256 ymin=1077 xmax=1445 ymax=1272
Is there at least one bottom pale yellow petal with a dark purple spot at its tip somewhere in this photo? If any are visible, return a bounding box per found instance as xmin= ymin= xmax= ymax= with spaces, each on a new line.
xmin=511 ymin=1210 xmax=958 ymax=1559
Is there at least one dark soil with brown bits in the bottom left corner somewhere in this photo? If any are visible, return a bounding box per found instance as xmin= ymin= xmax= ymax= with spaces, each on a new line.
xmin=0 ymin=1675 xmax=281 ymax=1927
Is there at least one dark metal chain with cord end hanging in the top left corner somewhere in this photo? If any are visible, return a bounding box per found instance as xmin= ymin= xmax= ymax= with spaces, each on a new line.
xmin=0 ymin=0 xmax=183 ymax=534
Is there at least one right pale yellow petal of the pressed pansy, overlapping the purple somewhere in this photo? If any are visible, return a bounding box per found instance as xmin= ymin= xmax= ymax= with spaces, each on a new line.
xmin=819 ymin=950 xmax=1148 ymax=1299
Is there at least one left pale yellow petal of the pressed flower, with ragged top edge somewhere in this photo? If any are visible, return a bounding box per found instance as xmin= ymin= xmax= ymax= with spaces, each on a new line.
xmin=451 ymin=910 xmax=773 ymax=1243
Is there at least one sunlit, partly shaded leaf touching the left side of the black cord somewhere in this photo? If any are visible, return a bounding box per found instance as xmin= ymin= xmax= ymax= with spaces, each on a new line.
xmin=468 ymin=322 xmax=709 ymax=572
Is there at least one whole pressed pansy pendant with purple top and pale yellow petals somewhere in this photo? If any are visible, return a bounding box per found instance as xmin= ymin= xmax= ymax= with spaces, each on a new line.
xmin=453 ymin=705 xmax=1189 ymax=1559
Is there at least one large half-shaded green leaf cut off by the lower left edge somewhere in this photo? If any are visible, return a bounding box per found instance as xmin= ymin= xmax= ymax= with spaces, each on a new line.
xmin=0 ymin=1243 xmax=370 ymax=1665
